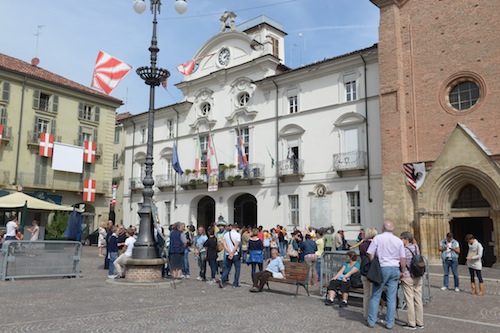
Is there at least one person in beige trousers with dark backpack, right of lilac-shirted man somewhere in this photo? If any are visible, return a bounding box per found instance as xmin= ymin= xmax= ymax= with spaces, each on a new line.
xmin=401 ymin=231 xmax=425 ymax=330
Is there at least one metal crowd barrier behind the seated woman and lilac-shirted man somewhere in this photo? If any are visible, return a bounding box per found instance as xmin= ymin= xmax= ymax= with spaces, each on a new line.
xmin=320 ymin=251 xmax=432 ymax=309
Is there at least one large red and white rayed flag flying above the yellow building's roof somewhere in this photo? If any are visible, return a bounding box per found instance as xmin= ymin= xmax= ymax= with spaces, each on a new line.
xmin=92 ymin=51 xmax=132 ymax=95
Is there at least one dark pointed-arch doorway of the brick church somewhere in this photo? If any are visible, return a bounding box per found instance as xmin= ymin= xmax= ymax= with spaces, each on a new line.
xmin=450 ymin=184 xmax=496 ymax=267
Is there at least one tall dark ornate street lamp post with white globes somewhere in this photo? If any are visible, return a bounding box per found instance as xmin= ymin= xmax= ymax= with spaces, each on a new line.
xmin=132 ymin=0 xmax=187 ymax=259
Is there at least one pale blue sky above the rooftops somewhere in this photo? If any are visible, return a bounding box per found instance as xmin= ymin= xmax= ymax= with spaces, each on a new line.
xmin=0 ymin=0 xmax=379 ymax=114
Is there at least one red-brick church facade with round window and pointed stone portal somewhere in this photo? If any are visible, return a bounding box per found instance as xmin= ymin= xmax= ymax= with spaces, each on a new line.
xmin=372 ymin=0 xmax=500 ymax=266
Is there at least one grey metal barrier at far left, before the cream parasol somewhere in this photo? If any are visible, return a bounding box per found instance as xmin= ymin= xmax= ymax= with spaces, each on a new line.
xmin=0 ymin=240 xmax=82 ymax=281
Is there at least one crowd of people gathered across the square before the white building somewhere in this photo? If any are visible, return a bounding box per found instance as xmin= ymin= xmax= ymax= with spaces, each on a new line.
xmin=94 ymin=215 xmax=484 ymax=330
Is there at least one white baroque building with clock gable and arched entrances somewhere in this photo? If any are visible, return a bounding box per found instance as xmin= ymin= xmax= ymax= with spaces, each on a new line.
xmin=123 ymin=16 xmax=383 ymax=239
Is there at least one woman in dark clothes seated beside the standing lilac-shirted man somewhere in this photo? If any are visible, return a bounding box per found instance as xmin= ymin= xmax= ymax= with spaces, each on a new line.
xmin=325 ymin=251 xmax=360 ymax=308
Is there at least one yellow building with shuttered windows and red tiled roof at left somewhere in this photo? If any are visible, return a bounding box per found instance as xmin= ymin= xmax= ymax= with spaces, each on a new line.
xmin=0 ymin=54 xmax=122 ymax=232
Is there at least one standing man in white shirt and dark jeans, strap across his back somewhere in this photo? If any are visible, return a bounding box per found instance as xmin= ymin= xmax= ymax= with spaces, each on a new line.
xmin=219 ymin=225 xmax=241 ymax=288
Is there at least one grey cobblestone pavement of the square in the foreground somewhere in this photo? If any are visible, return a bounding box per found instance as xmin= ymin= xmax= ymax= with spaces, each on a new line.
xmin=0 ymin=247 xmax=500 ymax=333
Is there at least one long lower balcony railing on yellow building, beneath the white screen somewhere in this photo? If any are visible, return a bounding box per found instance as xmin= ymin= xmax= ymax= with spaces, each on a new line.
xmin=17 ymin=172 xmax=111 ymax=193
